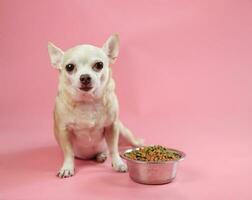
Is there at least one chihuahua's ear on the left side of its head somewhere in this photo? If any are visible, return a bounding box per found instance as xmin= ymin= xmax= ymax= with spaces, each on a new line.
xmin=48 ymin=42 xmax=64 ymax=69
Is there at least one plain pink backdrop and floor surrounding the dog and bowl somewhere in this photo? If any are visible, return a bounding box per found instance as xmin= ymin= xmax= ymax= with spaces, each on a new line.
xmin=0 ymin=0 xmax=252 ymax=200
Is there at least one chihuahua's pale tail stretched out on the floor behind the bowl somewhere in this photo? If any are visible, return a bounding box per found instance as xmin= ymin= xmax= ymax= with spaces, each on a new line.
xmin=118 ymin=121 xmax=144 ymax=147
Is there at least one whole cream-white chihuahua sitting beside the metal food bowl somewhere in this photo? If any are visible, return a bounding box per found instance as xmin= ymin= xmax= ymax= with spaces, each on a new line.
xmin=48 ymin=34 xmax=143 ymax=178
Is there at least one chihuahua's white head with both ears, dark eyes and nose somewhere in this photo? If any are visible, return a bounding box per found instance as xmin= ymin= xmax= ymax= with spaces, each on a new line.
xmin=48 ymin=34 xmax=119 ymax=100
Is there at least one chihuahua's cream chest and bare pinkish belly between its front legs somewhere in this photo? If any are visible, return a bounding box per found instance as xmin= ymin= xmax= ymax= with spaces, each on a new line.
xmin=66 ymin=104 xmax=107 ymax=154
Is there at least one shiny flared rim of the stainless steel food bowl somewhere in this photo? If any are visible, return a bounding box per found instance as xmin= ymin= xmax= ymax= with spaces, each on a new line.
xmin=120 ymin=145 xmax=186 ymax=164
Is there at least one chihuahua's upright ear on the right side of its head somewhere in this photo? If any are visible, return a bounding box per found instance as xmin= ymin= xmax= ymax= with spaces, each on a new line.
xmin=102 ymin=34 xmax=119 ymax=63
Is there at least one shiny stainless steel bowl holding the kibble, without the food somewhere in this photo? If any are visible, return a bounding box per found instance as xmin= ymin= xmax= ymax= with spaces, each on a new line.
xmin=120 ymin=148 xmax=185 ymax=184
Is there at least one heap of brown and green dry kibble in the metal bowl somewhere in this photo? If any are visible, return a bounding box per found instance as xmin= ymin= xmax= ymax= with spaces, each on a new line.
xmin=125 ymin=145 xmax=181 ymax=162
